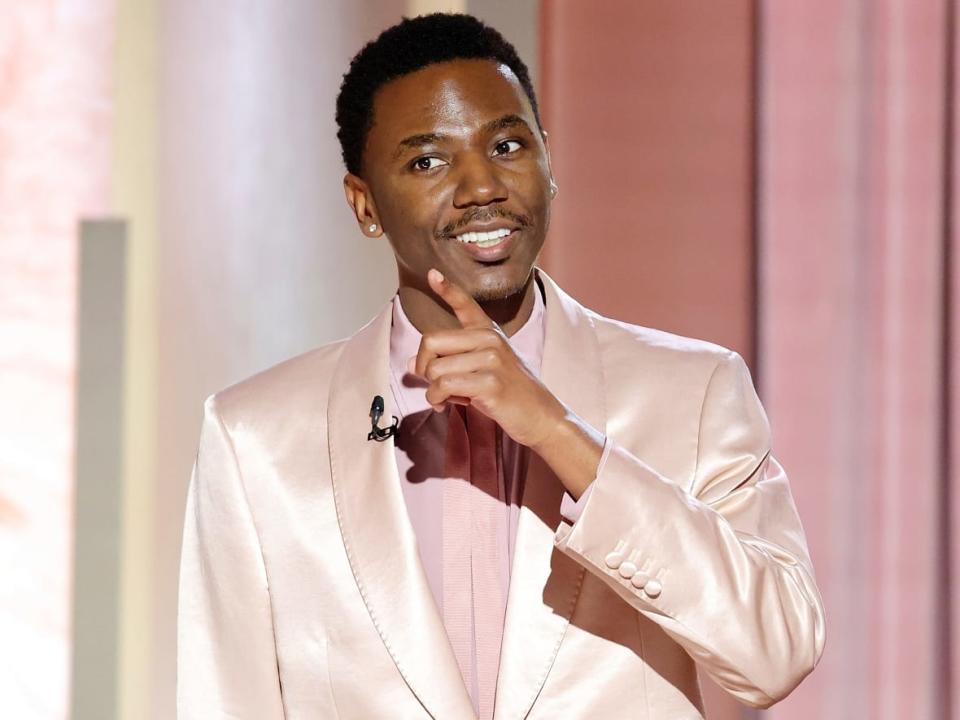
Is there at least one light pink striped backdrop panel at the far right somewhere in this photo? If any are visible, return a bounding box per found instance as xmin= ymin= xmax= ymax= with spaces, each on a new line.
xmin=758 ymin=0 xmax=957 ymax=720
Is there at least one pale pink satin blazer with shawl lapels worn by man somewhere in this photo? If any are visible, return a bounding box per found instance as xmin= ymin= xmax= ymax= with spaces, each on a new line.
xmin=177 ymin=269 xmax=824 ymax=720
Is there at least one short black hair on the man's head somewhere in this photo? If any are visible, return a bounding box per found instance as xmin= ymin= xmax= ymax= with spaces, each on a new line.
xmin=337 ymin=13 xmax=542 ymax=175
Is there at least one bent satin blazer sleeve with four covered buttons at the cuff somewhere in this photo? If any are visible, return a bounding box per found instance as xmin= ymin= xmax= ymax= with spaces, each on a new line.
xmin=555 ymin=351 xmax=825 ymax=707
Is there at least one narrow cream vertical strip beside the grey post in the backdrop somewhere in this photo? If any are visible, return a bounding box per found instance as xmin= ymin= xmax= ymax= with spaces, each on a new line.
xmin=111 ymin=0 xmax=158 ymax=720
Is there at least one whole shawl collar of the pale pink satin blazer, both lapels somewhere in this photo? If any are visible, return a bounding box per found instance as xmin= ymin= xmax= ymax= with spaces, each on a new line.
xmin=327 ymin=268 xmax=606 ymax=720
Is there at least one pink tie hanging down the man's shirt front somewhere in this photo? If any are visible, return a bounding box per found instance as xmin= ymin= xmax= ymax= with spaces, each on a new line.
xmin=443 ymin=405 xmax=507 ymax=720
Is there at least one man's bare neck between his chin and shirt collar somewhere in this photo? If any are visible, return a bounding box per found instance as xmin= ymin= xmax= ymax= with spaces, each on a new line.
xmin=399 ymin=272 xmax=536 ymax=337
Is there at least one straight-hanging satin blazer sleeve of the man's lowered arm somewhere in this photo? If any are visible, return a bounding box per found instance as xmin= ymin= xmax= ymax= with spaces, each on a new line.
xmin=177 ymin=397 xmax=283 ymax=720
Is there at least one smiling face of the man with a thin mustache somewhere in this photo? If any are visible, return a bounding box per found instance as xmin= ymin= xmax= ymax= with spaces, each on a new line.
xmin=350 ymin=60 xmax=551 ymax=302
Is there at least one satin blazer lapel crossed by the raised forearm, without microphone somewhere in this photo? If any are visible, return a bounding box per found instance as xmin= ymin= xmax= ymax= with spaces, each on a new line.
xmin=494 ymin=268 xmax=606 ymax=720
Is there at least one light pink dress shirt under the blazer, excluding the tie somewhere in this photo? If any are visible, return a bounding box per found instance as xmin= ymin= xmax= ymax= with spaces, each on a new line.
xmin=390 ymin=285 xmax=593 ymax=709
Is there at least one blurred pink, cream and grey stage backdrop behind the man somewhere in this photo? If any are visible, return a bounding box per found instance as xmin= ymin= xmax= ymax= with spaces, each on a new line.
xmin=0 ymin=0 xmax=960 ymax=720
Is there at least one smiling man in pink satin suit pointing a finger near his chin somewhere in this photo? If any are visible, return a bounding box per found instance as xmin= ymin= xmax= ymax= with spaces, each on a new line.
xmin=178 ymin=15 xmax=824 ymax=720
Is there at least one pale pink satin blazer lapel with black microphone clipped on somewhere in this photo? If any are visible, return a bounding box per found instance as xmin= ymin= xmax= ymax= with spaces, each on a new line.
xmin=327 ymin=303 xmax=473 ymax=718
